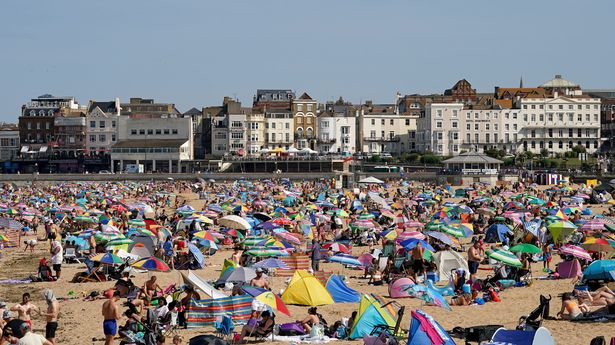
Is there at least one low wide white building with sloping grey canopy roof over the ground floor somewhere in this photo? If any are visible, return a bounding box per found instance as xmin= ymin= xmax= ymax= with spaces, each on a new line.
xmin=111 ymin=114 xmax=193 ymax=173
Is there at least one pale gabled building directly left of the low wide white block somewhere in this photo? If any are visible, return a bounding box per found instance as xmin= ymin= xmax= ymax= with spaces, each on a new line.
xmin=85 ymin=98 xmax=121 ymax=154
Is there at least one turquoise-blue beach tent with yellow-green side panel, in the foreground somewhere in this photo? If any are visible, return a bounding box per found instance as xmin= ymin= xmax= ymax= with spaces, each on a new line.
xmin=350 ymin=294 xmax=397 ymax=339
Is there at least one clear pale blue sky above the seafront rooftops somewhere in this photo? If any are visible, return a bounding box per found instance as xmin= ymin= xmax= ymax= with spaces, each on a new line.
xmin=0 ymin=0 xmax=615 ymax=123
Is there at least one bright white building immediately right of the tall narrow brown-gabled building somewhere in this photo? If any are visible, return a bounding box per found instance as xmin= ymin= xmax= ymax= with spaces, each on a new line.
xmin=317 ymin=112 xmax=357 ymax=154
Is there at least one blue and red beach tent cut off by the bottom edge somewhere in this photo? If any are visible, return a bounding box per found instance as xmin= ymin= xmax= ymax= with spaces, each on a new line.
xmin=408 ymin=310 xmax=455 ymax=345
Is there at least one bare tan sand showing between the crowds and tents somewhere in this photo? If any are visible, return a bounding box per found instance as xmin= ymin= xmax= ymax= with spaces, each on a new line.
xmin=0 ymin=189 xmax=615 ymax=344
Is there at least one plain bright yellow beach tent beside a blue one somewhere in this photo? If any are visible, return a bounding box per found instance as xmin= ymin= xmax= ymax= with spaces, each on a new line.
xmin=282 ymin=270 xmax=334 ymax=306
